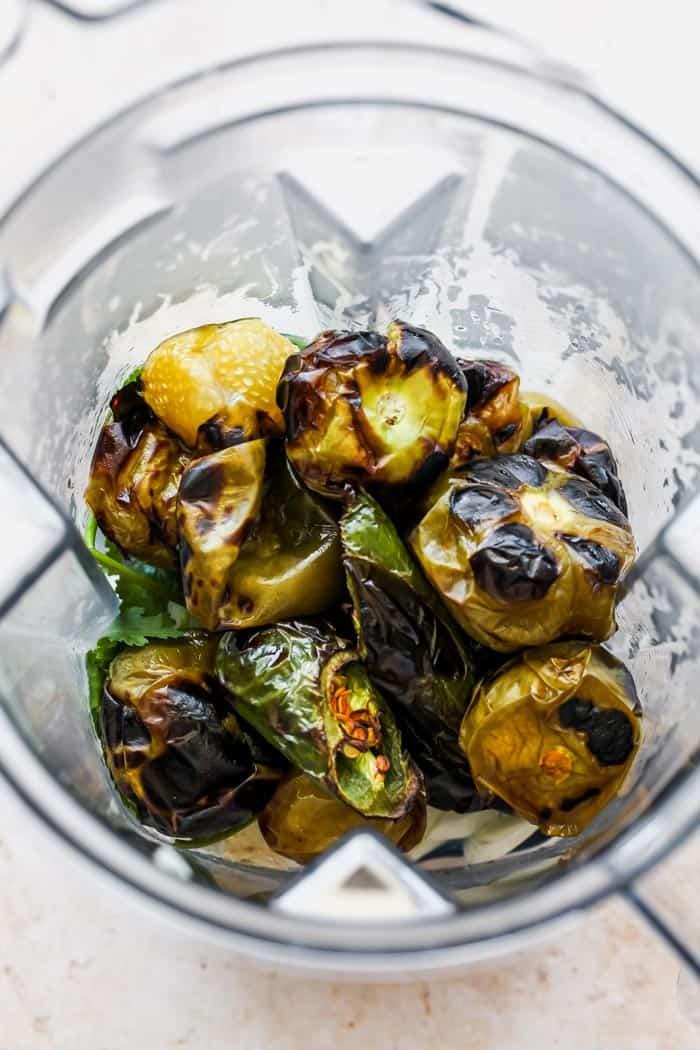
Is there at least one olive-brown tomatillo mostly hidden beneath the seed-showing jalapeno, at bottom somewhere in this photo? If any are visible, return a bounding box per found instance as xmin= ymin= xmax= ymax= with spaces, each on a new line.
xmin=258 ymin=772 xmax=425 ymax=864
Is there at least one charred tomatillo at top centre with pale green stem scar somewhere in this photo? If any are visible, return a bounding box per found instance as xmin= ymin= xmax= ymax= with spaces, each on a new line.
xmin=277 ymin=321 xmax=466 ymax=497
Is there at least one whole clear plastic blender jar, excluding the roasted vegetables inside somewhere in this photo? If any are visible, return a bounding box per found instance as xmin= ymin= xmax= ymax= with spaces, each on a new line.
xmin=0 ymin=0 xmax=700 ymax=977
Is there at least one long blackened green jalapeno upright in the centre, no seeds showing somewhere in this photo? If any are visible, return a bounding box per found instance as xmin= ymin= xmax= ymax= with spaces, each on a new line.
xmin=340 ymin=491 xmax=478 ymax=811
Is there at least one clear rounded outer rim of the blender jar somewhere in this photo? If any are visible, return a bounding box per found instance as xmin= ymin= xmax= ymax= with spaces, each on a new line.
xmin=0 ymin=30 xmax=700 ymax=973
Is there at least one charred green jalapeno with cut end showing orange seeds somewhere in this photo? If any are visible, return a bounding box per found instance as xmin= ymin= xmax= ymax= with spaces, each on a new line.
xmin=217 ymin=623 xmax=422 ymax=820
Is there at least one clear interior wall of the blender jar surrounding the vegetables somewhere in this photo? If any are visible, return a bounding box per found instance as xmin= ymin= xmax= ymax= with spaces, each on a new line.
xmin=0 ymin=47 xmax=700 ymax=936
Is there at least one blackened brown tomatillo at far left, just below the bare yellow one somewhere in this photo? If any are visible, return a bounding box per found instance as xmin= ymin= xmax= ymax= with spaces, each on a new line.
xmin=85 ymin=383 xmax=189 ymax=568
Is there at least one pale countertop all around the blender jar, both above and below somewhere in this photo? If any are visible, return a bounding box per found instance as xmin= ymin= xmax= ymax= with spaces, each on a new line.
xmin=0 ymin=0 xmax=700 ymax=1050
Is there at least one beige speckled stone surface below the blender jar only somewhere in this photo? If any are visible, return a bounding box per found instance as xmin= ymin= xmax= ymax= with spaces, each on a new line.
xmin=0 ymin=789 xmax=700 ymax=1050
